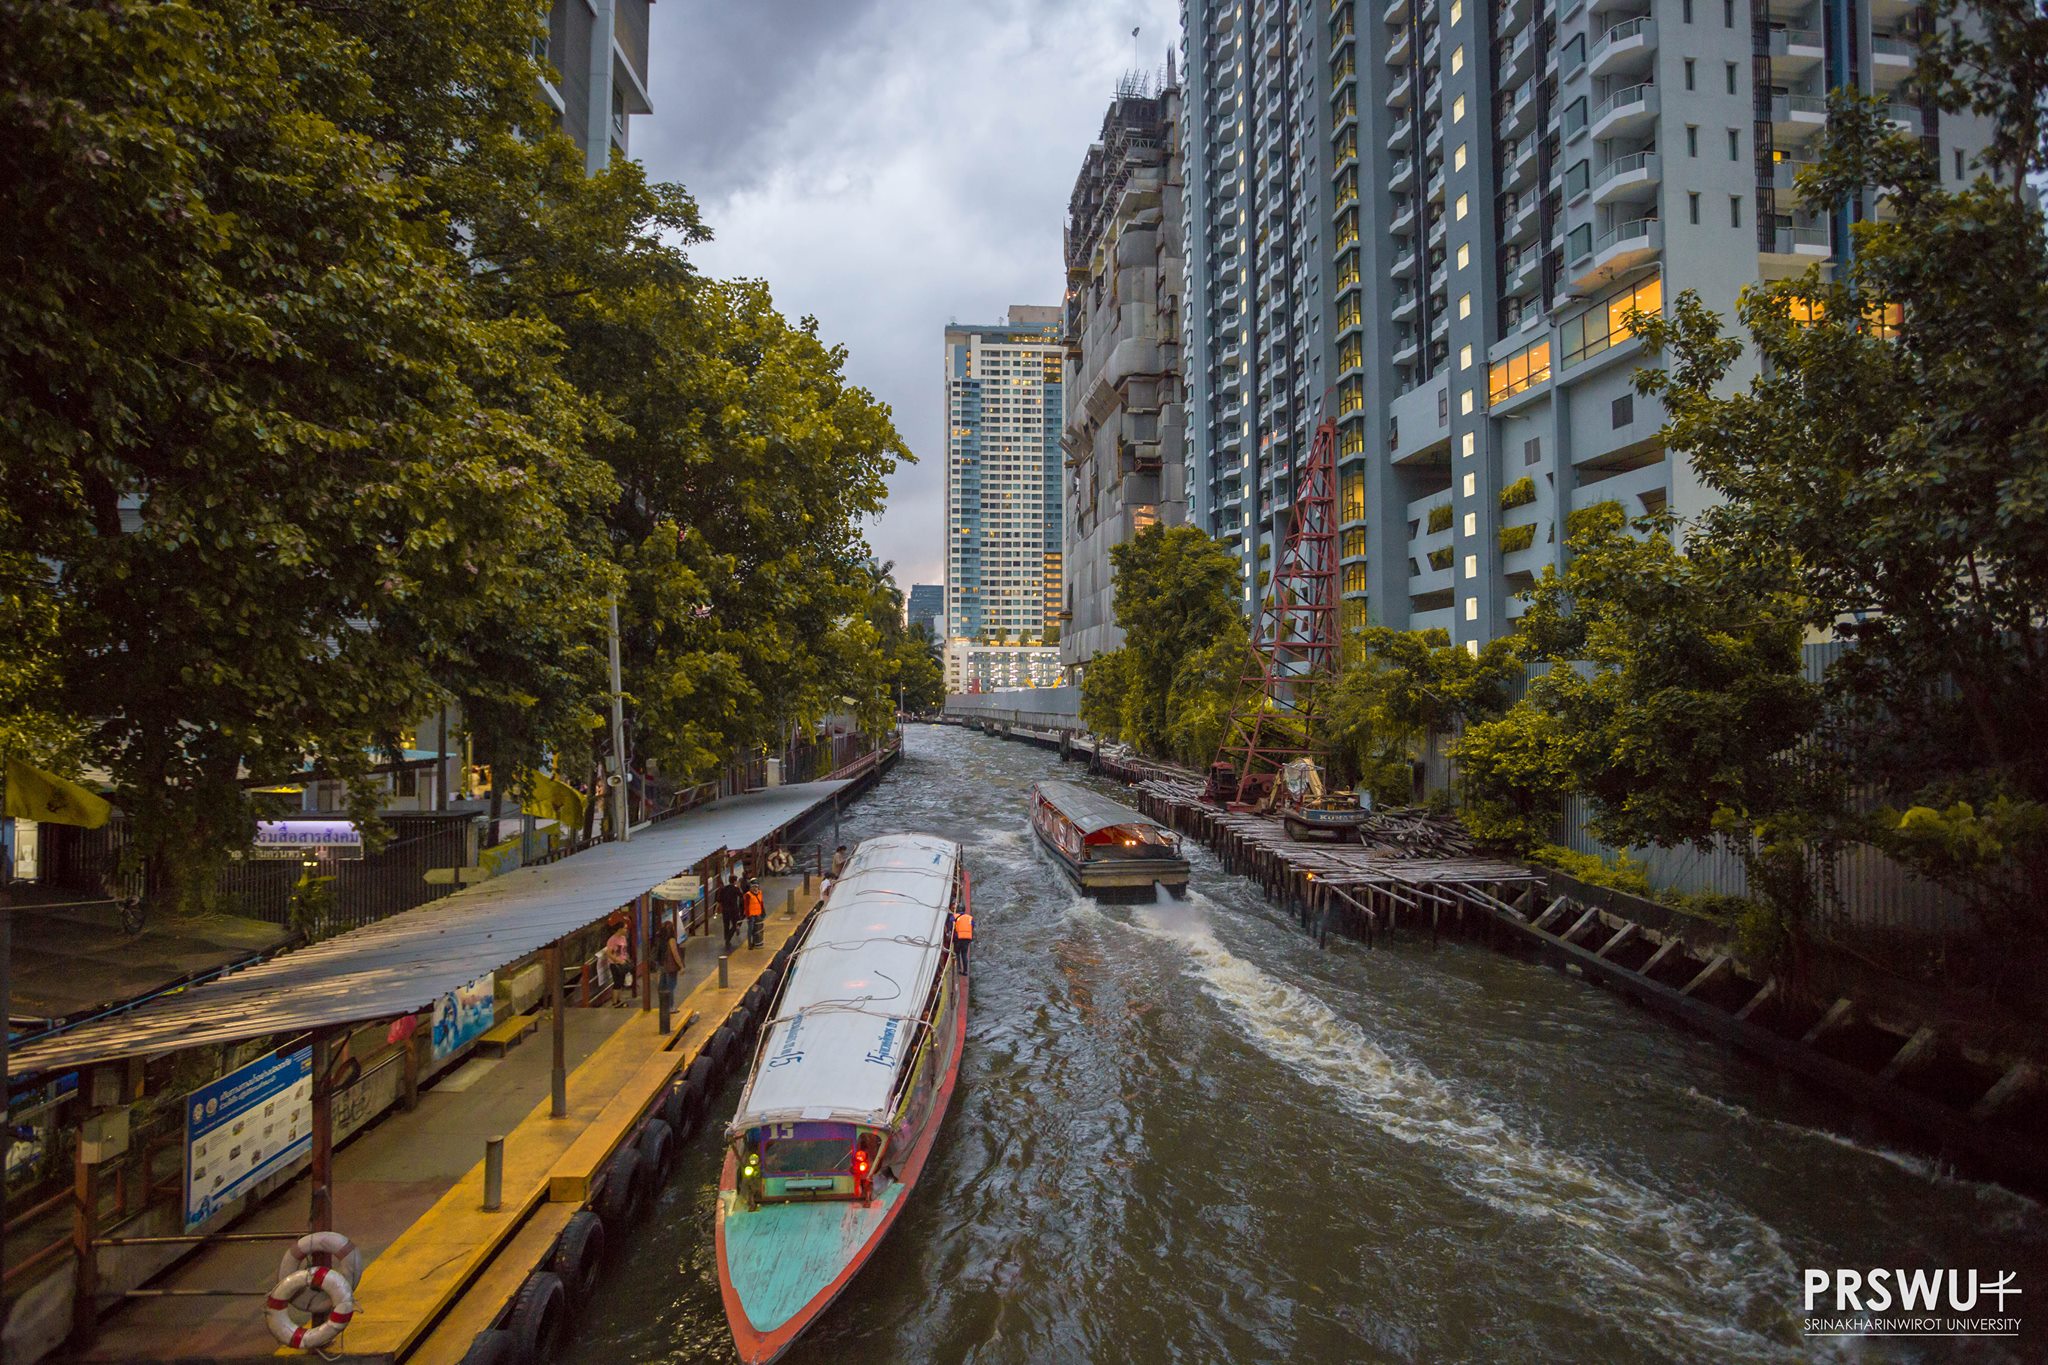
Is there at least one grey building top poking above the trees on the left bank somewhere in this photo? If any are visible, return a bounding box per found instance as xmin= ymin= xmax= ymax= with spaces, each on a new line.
xmin=541 ymin=0 xmax=653 ymax=174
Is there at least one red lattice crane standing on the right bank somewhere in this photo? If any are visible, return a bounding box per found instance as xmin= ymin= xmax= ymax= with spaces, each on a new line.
xmin=1208 ymin=417 xmax=1337 ymax=806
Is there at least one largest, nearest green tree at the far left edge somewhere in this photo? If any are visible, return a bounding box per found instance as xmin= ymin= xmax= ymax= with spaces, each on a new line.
xmin=0 ymin=0 xmax=610 ymax=907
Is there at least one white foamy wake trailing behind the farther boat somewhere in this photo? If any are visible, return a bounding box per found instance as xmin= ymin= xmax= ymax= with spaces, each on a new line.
xmin=1122 ymin=892 xmax=1810 ymax=1359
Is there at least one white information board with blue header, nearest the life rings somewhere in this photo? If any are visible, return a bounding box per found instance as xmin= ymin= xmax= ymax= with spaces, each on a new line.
xmin=184 ymin=1044 xmax=313 ymax=1232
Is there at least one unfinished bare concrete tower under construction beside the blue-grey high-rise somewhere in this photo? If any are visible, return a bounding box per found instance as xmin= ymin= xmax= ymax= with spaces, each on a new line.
xmin=1059 ymin=65 xmax=1188 ymax=675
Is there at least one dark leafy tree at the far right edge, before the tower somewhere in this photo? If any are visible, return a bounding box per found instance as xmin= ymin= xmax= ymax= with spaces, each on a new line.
xmin=1640 ymin=42 xmax=2048 ymax=933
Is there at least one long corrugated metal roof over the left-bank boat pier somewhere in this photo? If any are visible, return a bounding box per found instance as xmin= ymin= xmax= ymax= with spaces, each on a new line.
xmin=8 ymin=782 xmax=848 ymax=1076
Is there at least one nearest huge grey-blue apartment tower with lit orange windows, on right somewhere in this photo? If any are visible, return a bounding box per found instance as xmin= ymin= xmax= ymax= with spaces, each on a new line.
xmin=1318 ymin=0 xmax=1989 ymax=647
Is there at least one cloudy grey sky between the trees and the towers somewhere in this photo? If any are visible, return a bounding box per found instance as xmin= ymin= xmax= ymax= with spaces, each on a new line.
xmin=633 ymin=0 xmax=1180 ymax=587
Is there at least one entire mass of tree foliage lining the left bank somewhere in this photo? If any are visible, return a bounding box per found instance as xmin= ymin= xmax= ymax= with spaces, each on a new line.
xmin=0 ymin=0 xmax=909 ymax=907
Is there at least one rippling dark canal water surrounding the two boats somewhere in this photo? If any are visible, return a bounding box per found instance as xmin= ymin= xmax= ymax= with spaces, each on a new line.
xmin=569 ymin=726 xmax=2048 ymax=1365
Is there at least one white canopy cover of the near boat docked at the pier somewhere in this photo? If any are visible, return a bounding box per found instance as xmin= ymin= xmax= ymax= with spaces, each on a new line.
xmin=731 ymin=835 xmax=961 ymax=1134
